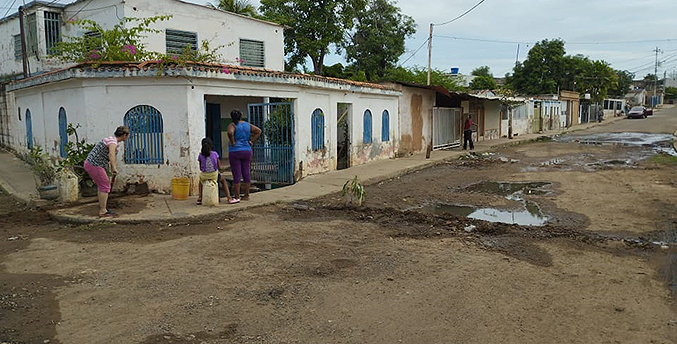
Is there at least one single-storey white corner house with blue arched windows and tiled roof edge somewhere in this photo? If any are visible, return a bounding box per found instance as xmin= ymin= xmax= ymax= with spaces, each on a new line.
xmin=7 ymin=63 xmax=401 ymax=191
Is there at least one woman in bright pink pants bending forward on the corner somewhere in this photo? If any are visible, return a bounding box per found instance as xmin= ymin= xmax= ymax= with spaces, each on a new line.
xmin=84 ymin=125 xmax=129 ymax=217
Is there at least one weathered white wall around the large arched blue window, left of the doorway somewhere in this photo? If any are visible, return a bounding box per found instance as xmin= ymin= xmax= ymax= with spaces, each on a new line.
xmin=13 ymin=78 xmax=195 ymax=191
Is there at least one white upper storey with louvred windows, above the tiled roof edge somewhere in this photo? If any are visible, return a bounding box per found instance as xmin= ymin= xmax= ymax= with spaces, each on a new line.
xmin=0 ymin=0 xmax=284 ymax=75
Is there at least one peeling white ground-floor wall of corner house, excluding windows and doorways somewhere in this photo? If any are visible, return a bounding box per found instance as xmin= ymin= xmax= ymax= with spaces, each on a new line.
xmin=10 ymin=67 xmax=400 ymax=191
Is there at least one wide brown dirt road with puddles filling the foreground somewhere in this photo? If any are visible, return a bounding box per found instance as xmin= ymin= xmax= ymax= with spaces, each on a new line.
xmin=0 ymin=110 xmax=677 ymax=343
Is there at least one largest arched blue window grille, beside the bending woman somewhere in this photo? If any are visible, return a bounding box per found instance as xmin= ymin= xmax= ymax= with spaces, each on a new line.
xmin=124 ymin=105 xmax=164 ymax=165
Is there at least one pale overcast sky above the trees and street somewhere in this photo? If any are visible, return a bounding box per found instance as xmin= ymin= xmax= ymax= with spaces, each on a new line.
xmin=25 ymin=0 xmax=677 ymax=78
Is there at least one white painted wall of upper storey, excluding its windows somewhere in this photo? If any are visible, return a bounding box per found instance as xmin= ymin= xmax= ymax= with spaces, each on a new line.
xmin=0 ymin=0 xmax=284 ymax=75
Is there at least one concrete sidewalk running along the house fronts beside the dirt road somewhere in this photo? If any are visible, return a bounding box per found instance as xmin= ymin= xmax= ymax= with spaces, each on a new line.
xmin=0 ymin=117 xmax=623 ymax=223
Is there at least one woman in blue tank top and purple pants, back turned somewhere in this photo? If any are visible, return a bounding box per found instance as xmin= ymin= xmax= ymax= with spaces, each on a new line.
xmin=228 ymin=110 xmax=261 ymax=201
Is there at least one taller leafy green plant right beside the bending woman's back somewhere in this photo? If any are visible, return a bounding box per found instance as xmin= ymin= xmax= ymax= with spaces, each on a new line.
xmin=59 ymin=123 xmax=96 ymax=197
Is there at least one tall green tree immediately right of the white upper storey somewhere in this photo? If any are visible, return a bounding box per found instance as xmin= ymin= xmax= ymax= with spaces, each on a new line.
xmin=259 ymin=0 xmax=353 ymax=75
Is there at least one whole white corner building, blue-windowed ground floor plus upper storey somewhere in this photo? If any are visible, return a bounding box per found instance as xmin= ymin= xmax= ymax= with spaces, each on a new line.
xmin=0 ymin=0 xmax=401 ymax=191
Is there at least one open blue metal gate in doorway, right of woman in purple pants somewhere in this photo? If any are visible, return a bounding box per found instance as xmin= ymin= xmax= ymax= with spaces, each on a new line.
xmin=248 ymin=103 xmax=294 ymax=184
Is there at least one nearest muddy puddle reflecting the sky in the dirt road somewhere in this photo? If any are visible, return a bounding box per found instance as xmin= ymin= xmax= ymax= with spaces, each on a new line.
xmin=410 ymin=182 xmax=550 ymax=226
